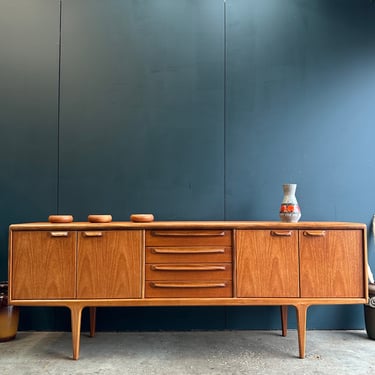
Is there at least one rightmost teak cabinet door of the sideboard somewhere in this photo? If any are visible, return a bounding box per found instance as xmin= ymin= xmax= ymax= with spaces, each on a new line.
xmin=299 ymin=230 xmax=365 ymax=297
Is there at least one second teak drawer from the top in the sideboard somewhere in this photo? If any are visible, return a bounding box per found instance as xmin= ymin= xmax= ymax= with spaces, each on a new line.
xmin=146 ymin=246 xmax=232 ymax=263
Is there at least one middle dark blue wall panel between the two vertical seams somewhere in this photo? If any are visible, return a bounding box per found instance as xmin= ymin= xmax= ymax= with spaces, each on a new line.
xmin=59 ymin=0 xmax=224 ymax=219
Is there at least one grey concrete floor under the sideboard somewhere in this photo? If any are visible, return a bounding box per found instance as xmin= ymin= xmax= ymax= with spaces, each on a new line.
xmin=0 ymin=330 xmax=375 ymax=375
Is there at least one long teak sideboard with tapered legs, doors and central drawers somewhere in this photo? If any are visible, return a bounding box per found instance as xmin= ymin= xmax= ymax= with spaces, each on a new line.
xmin=9 ymin=221 xmax=368 ymax=359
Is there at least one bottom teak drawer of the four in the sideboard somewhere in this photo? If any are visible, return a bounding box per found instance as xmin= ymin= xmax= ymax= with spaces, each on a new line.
xmin=145 ymin=281 xmax=233 ymax=298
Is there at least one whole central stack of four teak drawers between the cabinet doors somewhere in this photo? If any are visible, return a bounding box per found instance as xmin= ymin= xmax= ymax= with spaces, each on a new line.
xmin=145 ymin=230 xmax=233 ymax=298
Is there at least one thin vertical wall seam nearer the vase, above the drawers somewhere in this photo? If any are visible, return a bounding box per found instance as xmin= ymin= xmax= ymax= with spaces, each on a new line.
xmin=223 ymin=0 xmax=227 ymax=220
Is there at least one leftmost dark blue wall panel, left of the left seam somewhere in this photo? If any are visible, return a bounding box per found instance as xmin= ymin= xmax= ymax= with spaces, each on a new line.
xmin=0 ymin=0 xmax=59 ymax=279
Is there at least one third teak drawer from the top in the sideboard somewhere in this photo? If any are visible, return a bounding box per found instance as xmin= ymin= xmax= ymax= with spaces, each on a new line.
xmin=146 ymin=263 xmax=232 ymax=281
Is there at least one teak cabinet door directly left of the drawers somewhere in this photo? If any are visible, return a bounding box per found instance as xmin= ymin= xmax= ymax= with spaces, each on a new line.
xmin=77 ymin=230 xmax=143 ymax=298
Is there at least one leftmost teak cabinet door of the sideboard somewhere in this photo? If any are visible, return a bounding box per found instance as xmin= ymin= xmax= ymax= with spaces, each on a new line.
xmin=11 ymin=231 xmax=76 ymax=299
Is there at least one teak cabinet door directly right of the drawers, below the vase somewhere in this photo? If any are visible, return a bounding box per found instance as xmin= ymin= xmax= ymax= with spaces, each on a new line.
xmin=235 ymin=230 xmax=299 ymax=297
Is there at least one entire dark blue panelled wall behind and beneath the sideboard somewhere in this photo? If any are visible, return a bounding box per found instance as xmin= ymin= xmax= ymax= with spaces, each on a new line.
xmin=0 ymin=0 xmax=375 ymax=330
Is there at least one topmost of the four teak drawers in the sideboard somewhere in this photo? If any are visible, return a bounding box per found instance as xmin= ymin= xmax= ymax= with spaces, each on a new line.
xmin=146 ymin=229 xmax=232 ymax=246
